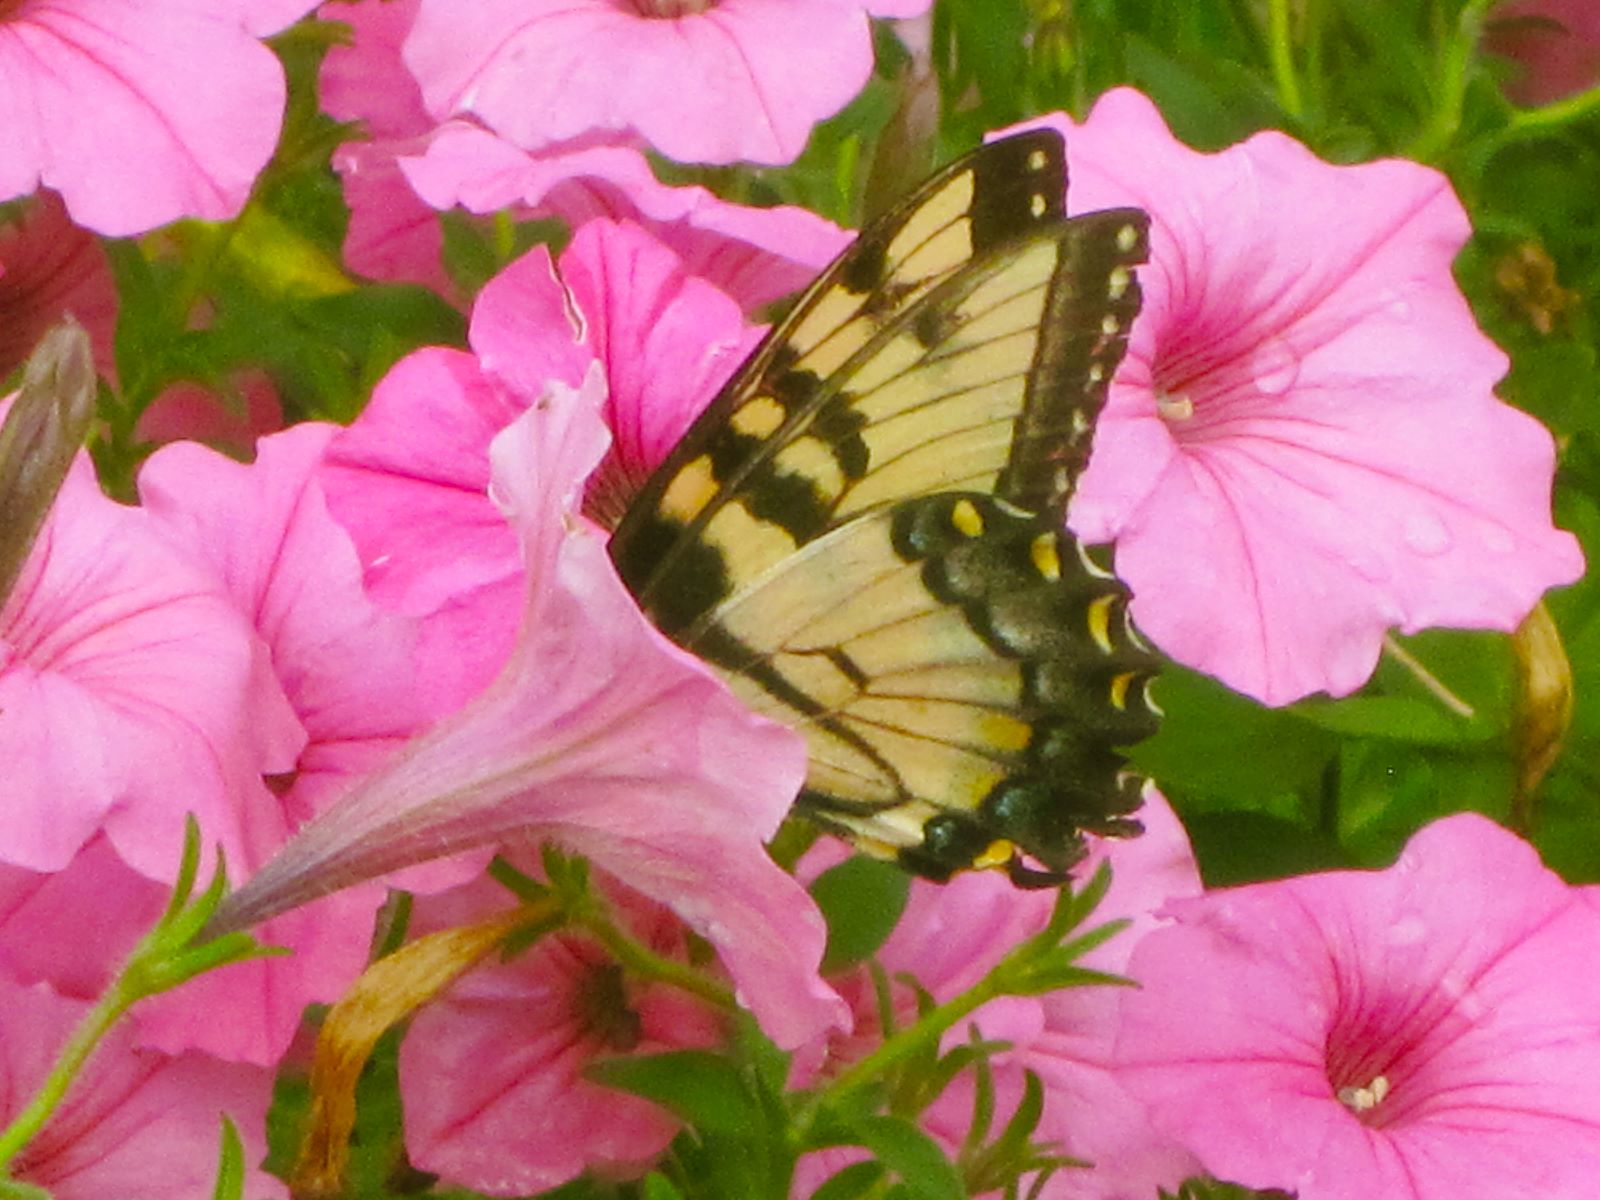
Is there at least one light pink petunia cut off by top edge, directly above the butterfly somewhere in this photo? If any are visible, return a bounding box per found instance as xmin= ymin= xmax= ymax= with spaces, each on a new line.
xmin=405 ymin=0 xmax=926 ymax=163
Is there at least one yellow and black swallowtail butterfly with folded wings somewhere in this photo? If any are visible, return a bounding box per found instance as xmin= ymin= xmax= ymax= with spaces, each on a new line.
xmin=611 ymin=130 xmax=1158 ymax=885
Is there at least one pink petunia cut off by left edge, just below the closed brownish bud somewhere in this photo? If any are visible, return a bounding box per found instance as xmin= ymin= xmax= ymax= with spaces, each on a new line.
xmin=0 ymin=441 xmax=304 ymax=882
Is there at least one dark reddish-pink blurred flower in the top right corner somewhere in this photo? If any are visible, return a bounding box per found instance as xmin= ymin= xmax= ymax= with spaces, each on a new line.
xmin=1483 ymin=0 xmax=1600 ymax=104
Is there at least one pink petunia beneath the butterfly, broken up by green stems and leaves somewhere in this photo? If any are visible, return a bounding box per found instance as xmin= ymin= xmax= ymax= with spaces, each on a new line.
xmin=794 ymin=787 xmax=1200 ymax=1200
